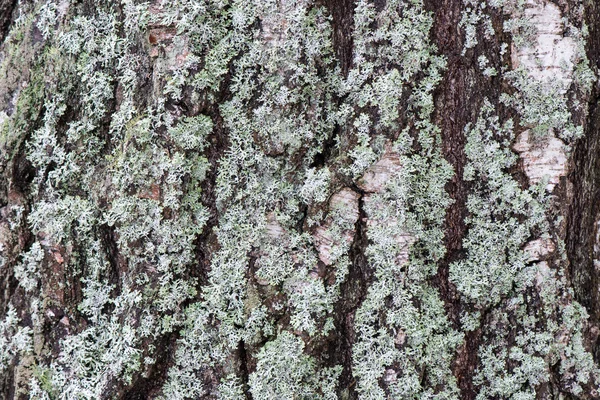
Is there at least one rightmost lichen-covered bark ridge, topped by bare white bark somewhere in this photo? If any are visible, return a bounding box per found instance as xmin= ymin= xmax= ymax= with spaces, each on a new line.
xmin=449 ymin=1 xmax=600 ymax=399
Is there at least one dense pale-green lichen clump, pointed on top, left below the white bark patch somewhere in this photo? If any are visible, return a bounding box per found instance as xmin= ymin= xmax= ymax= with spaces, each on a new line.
xmin=449 ymin=102 xmax=545 ymax=308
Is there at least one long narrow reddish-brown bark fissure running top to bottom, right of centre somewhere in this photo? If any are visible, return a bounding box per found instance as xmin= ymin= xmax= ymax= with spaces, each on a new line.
xmin=429 ymin=0 xmax=478 ymax=400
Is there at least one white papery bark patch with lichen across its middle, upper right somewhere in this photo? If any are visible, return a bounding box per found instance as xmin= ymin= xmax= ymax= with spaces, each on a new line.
xmin=501 ymin=0 xmax=594 ymax=191
